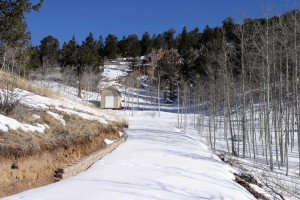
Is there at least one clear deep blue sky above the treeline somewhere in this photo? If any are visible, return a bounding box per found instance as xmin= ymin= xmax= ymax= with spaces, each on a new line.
xmin=27 ymin=0 xmax=295 ymax=45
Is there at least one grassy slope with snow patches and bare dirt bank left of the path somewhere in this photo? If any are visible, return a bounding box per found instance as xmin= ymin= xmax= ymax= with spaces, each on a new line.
xmin=0 ymin=72 xmax=127 ymax=196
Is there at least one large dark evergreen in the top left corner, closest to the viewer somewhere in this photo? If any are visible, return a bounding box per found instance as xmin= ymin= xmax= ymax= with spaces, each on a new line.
xmin=0 ymin=0 xmax=43 ymax=75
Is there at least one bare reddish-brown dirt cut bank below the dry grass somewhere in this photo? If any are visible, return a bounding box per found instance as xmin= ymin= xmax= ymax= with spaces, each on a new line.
xmin=0 ymin=131 xmax=118 ymax=198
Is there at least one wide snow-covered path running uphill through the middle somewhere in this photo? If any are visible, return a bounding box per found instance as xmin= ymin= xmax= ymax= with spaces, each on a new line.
xmin=6 ymin=116 xmax=255 ymax=200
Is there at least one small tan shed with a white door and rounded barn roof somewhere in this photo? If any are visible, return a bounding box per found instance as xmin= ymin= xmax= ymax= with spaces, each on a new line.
xmin=100 ymin=87 xmax=122 ymax=109
